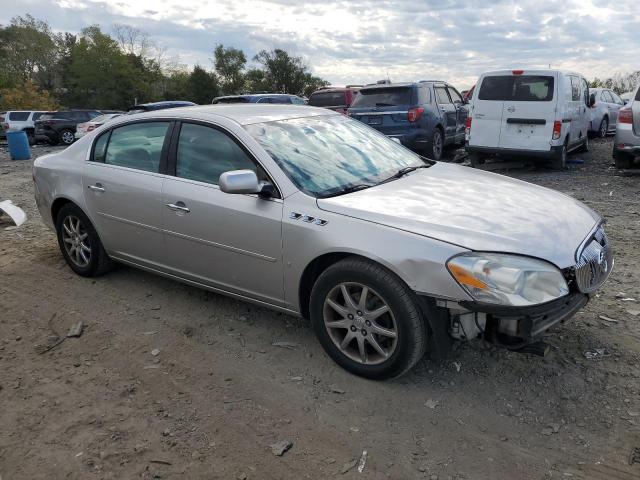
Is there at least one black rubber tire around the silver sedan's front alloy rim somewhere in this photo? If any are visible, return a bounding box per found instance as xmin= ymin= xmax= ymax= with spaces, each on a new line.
xmin=310 ymin=257 xmax=428 ymax=380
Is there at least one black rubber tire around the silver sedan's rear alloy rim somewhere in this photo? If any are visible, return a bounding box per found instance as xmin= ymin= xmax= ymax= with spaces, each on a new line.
xmin=56 ymin=203 xmax=113 ymax=277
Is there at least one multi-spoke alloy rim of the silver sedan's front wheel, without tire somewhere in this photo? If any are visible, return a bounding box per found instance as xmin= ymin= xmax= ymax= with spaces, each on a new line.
xmin=323 ymin=282 xmax=398 ymax=365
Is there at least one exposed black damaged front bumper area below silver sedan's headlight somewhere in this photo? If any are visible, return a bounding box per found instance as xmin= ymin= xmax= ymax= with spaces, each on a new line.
xmin=436 ymin=292 xmax=589 ymax=350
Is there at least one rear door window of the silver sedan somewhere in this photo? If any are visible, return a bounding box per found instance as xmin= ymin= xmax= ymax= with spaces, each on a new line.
xmin=102 ymin=122 xmax=170 ymax=173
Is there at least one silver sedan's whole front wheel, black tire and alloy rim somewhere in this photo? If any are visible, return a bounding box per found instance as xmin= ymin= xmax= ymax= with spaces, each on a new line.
xmin=310 ymin=257 xmax=427 ymax=379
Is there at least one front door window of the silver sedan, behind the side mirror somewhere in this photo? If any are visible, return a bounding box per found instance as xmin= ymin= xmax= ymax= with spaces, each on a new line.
xmin=176 ymin=123 xmax=264 ymax=185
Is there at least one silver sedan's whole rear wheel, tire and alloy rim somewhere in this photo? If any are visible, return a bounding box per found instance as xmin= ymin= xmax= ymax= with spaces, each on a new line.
xmin=56 ymin=203 xmax=113 ymax=277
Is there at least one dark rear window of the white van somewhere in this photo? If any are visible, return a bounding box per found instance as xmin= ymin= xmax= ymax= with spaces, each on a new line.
xmin=478 ymin=75 xmax=554 ymax=102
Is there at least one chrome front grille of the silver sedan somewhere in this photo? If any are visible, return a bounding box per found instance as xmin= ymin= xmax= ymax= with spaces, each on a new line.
xmin=576 ymin=225 xmax=613 ymax=293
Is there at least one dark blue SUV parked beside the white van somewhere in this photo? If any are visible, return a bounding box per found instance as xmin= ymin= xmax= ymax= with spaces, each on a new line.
xmin=347 ymin=80 xmax=467 ymax=160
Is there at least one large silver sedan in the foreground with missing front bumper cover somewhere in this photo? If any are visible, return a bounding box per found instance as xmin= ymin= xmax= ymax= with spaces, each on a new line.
xmin=33 ymin=105 xmax=613 ymax=378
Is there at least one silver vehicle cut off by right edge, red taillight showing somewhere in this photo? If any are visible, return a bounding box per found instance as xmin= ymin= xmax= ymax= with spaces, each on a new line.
xmin=613 ymin=86 xmax=640 ymax=168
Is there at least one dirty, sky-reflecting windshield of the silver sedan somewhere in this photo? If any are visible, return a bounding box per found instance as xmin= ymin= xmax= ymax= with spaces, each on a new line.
xmin=245 ymin=115 xmax=425 ymax=197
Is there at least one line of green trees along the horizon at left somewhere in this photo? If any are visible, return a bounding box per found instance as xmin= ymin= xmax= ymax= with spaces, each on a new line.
xmin=0 ymin=15 xmax=328 ymax=110
